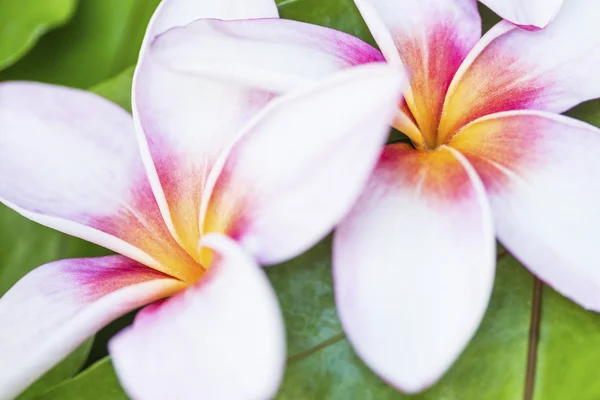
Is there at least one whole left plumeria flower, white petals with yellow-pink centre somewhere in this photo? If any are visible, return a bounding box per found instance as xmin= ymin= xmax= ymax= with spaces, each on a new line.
xmin=0 ymin=0 xmax=404 ymax=399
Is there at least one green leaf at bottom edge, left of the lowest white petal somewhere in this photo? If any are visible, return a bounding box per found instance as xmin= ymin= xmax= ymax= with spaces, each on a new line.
xmin=35 ymin=357 xmax=129 ymax=400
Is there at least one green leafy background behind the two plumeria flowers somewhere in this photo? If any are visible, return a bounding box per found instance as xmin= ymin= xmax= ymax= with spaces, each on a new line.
xmin=0 ymin=0 xmax=600 ymax=400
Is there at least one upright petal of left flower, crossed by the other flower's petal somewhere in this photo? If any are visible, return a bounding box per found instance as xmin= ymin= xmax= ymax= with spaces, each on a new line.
xmin=132 ymin=0 xmax=278 ymax=261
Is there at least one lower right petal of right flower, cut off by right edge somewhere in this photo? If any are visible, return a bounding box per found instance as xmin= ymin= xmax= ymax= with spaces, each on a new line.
xmin=450 ymin=111 xmax=600 ymax=311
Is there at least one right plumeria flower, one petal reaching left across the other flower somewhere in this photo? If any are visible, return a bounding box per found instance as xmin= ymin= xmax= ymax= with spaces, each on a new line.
xmin=152 ymin=0 xmax=600 ymax=392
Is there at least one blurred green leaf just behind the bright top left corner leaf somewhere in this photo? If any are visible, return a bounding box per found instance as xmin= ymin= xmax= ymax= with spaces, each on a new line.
xmin=0 ymin=0 xmax=160 ymax=88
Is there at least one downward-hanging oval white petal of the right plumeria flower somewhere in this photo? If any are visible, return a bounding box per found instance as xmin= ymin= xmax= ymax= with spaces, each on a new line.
xmin=333 ymin=144 xmax=495 ymax=393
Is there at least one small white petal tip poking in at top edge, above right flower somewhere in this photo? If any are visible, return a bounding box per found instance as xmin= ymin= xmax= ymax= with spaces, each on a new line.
xmin=480 ymin=0 xmax=563 ymax=30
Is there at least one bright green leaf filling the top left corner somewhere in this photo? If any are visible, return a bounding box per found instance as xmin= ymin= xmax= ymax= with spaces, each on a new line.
xmin=0 ymin=0 xmax=77 ymax=70
